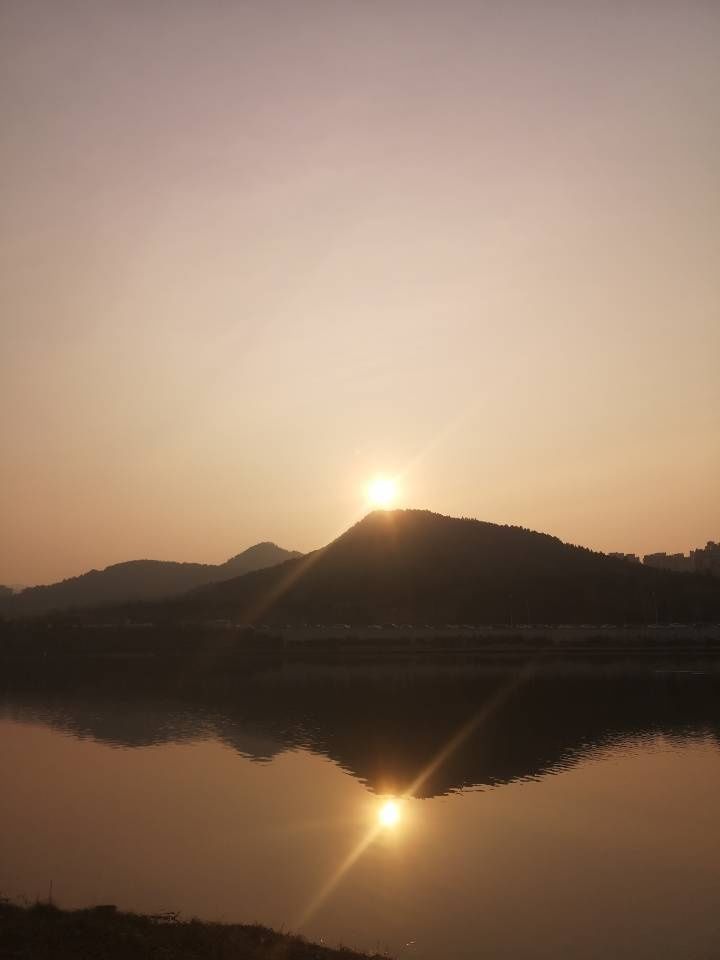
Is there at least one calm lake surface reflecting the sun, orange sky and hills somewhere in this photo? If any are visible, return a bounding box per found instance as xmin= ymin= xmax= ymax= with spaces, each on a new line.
xmin=0 ymin=660 xmax=720 ymax=960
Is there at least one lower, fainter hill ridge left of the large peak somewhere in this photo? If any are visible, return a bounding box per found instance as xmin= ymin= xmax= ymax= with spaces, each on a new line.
xmin=1 ymin=543 xmax=302 ymax=617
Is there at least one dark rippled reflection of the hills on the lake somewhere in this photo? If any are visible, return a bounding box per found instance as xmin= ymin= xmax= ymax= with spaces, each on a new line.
xmin=0 ymin=659 xmax=720 ymax=797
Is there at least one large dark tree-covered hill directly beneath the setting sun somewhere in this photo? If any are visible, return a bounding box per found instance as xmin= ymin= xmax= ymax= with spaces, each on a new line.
xmin=105 ymin=510 xmax=720 ymax=624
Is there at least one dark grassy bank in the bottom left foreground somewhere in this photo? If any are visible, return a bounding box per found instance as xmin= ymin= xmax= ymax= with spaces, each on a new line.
xmin=0 ymin=901 xmax=383 ymax=960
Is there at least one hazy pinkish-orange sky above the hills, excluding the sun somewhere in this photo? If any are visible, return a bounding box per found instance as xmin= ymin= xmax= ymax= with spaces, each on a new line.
xmin=0 ymin=0 xmax=720 ymax=583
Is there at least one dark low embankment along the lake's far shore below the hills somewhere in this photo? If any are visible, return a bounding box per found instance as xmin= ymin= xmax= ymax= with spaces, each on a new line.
xmin=0 ymin=621 xmax=720 ymax=662
